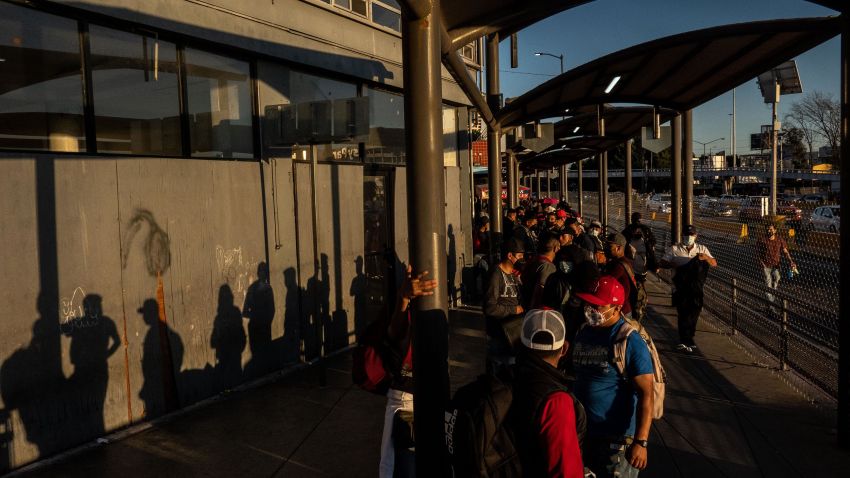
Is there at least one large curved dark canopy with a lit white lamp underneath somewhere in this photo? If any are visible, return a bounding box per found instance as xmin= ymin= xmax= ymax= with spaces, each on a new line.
xmin=497 ymin=17 xmax=841 ymax=127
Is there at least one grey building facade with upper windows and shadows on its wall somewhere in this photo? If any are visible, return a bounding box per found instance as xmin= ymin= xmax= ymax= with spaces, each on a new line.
xmin=0 ymin=0 xmax=480 ymax=471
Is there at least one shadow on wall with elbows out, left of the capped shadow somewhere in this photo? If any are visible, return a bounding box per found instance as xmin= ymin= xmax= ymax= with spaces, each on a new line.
xmin=60 ymin=294 xmax=121 ymax=437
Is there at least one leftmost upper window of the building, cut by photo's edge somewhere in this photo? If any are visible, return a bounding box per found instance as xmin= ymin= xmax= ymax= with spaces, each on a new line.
xmin=0 ymin=2 xmax=86 ymax=152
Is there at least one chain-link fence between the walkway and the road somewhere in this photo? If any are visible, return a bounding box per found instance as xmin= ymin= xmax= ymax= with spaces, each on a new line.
xmin=568 ymin=191 xmax=840 ymax=398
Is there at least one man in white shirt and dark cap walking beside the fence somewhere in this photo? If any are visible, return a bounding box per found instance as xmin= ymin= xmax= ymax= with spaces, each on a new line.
xmin=661 ymin=225 xmax=717 ymax=352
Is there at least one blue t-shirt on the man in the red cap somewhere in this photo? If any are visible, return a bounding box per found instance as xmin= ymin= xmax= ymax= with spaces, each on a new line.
xmin=573 ymin=319 xmax=654 ymax=438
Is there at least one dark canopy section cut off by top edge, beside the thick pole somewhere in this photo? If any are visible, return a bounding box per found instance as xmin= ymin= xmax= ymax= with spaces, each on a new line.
xmin=440 ymin=0 xmax=592 ymax=50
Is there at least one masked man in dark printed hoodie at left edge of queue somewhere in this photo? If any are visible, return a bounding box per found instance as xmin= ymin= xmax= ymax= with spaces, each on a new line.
xmin=484 ymin=238 xmax=525 ymax=372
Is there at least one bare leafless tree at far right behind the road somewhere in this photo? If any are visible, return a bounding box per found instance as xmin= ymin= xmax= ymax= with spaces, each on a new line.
xmin=785 ymin=91 xmax=841 ymax=164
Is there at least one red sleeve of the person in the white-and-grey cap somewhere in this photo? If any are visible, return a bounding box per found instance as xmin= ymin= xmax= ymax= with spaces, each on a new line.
xmin=537 ymin=392 xmax=584 ymax=478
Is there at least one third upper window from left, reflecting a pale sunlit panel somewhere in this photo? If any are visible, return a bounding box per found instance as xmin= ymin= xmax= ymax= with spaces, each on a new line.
xmin=185 ymin=48 xmax=254 ymax=158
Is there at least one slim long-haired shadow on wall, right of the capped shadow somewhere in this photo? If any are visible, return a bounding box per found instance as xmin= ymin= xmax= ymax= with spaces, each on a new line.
xmin=210 ymin=284 xmax=247 ymax=390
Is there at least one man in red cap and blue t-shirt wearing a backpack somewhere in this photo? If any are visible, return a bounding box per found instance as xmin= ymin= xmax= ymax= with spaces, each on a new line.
xmin=573 ymin=276 xmax=654 ymax=477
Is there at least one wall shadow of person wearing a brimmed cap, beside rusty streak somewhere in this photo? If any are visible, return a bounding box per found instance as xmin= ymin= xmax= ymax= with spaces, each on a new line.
xmin=138 ymin=299 xmax=183 ymax=418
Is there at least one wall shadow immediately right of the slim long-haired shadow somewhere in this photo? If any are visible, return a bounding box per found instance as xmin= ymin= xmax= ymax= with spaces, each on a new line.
xmin=242 ymin=262 xmax=278 ymax=377
